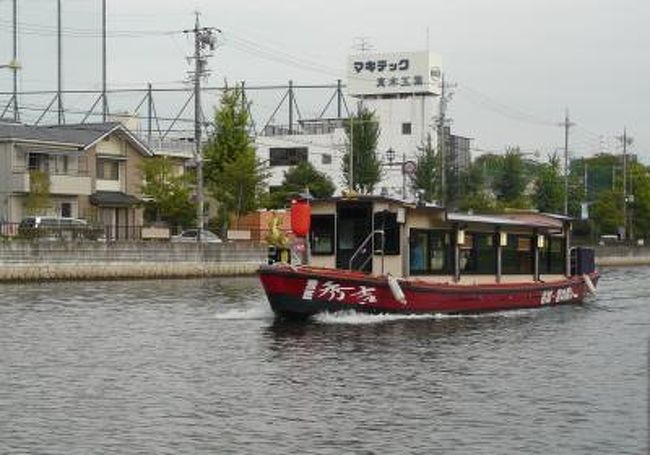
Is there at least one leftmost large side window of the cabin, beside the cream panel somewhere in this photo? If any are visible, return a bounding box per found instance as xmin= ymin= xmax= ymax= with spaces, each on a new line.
xmin=409 ymin=229 xmax=454 ymax=275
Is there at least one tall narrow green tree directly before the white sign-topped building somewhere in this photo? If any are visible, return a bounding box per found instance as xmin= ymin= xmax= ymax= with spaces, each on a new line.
xmin=343 ymin=107 xmax=382 ymax=194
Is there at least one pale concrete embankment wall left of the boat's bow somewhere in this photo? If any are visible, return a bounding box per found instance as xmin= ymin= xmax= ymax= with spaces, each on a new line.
xmin=0 ymin=241 xmax=267 ymax=282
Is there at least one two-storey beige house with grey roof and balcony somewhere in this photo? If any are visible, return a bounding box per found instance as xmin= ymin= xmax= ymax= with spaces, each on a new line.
xmin=0 ymin=122 xmax=153 ymax=238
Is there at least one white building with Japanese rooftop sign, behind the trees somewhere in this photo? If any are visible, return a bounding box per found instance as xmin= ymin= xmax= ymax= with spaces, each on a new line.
xmin=256 ymin=52 xmax=441 ymax=199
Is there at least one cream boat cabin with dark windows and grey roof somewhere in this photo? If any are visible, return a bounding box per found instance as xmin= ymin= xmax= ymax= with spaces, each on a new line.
xmin=309 ymin=196 xmax=571 ymax=284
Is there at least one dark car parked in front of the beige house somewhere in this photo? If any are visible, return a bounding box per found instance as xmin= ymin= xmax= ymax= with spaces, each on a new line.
xmin=18 ymin=216 xmax=102 ymax=240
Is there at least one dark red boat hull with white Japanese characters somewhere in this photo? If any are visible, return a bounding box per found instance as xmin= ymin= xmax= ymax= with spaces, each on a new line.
xmin=260 ymin=265 xmax=599 ymax=318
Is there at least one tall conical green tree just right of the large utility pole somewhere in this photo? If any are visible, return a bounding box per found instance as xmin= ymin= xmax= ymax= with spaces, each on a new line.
xmin=203 ymin=88 xmax=267 ymax=230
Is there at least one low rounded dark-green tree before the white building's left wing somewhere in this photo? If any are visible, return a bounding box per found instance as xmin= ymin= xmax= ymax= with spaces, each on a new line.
xmin=269 ymin=161 xmax=336 ymax=208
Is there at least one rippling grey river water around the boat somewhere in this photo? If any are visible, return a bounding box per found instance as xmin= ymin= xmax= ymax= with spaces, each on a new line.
xmin=0 ymin=268 xmax=650 ymax=455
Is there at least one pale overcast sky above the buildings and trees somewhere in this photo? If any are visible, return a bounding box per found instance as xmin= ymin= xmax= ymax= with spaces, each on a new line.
xmin=0 ymin=0 xmax=650 ymax=162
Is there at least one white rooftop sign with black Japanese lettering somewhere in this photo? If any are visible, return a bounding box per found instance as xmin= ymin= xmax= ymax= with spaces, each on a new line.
xmin=347 ymin=52 xmax=442 ymax=96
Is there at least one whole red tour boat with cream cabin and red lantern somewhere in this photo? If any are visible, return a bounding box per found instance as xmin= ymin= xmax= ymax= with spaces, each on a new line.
xmin=260 ymin=196 xmax=599 ymax=318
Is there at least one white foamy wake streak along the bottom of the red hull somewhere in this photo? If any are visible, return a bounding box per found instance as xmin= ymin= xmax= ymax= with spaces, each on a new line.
xmin=313 ymin=309 xmax=539 ymax=325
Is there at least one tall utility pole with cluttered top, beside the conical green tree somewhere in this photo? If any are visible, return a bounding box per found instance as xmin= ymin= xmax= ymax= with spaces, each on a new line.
xmin=183 ymin=11 xmax=220 ymax=242
